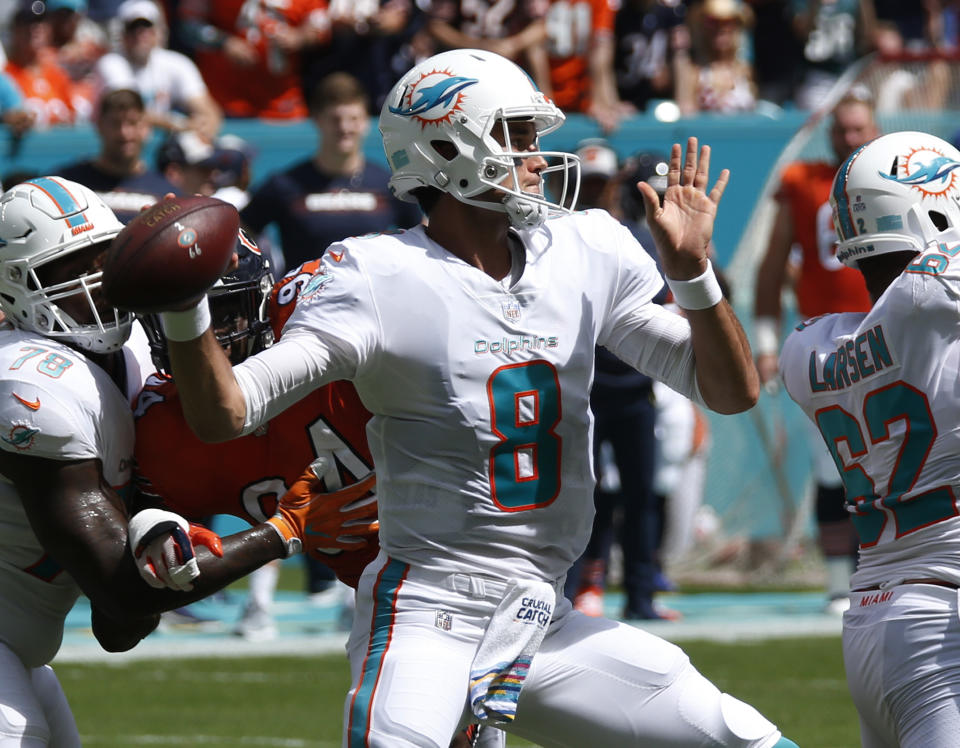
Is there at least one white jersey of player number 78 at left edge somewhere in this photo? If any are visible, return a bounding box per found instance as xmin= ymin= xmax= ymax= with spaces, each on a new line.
xmin=0 ymin=325 xmax=154 ymax=667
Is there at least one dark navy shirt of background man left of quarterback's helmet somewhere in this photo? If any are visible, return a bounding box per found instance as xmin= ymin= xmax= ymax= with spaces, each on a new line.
xmin=240 ymin=160 xmax=420 ymax=268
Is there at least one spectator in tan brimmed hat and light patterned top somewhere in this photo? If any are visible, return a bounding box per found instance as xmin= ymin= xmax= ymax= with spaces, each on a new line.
xmin=677 ymin=0 xmax=757 ymax=115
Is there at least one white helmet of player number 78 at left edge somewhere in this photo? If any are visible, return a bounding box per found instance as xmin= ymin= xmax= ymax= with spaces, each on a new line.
xmin=0 ymin=177 xmax=133 ymax=353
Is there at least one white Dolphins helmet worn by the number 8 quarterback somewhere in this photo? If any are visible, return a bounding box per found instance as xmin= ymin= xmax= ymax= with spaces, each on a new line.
xmin=380 ymin=49 xmax=580 ymax=229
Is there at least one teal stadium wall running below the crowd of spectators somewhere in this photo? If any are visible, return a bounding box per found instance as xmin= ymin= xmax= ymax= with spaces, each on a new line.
xmin=0 ymin=111 xmax=806 ymax=265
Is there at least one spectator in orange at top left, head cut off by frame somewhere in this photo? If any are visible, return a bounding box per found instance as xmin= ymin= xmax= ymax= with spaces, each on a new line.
xmin=178 ymin=0 xmax=330 ymax=119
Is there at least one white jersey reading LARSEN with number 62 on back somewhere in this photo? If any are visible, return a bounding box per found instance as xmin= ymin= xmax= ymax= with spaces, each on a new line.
xmin=780 ymin=243 xmax=960 ymax=589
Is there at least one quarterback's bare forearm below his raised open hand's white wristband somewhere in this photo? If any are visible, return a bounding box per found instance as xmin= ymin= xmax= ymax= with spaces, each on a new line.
xmin=686 ymin=300 xmax=760 ymax=413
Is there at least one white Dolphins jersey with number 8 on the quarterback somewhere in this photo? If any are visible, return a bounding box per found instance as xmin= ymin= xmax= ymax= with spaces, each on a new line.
xmin=234 ymin=210 xmax=700 ymax=580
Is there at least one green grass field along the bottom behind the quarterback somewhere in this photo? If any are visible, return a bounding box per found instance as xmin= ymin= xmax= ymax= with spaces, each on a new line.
xmin=55 ymin=638 xmax=859 ymax=748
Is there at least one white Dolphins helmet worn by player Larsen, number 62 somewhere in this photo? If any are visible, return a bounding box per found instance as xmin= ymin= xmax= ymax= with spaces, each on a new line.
xmin=830 ymin=132 xmax=960 ymax=267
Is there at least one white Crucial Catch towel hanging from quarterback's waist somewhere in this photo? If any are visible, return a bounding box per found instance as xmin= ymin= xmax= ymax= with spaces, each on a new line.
xmin=470 ymin=579 xmax=556 ymax=725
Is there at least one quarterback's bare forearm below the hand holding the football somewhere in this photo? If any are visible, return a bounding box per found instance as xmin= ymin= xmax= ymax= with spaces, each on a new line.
xmin=168 ymin=328 xmax=246 ymax=442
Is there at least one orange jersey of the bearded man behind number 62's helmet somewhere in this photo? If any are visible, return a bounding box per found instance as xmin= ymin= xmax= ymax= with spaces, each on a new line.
xmin=776 ymin=161 xmax=870 ymax=318
